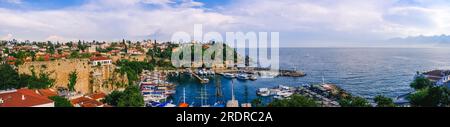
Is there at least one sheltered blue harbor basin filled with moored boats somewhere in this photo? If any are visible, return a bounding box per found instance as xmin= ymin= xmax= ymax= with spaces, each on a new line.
xmin=139 ymin=68 xmax=312 ymax=107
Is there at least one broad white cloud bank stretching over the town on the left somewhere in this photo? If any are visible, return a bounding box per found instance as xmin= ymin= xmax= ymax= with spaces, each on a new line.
xmin=0 ymin=0 xmax=233 ymax=40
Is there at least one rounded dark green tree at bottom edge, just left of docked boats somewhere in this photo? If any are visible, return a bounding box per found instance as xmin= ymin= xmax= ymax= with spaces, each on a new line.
xmin=117 ymin=85 xmax=145 ymax=107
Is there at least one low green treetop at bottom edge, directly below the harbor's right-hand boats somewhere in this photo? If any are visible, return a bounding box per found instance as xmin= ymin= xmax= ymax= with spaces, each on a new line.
xmin=268 ymin=94 xmax=319 ymax=107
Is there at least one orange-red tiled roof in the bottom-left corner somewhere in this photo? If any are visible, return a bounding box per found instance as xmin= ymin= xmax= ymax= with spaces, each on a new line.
xmin=0 ymin=89 xmax=55 ymax=107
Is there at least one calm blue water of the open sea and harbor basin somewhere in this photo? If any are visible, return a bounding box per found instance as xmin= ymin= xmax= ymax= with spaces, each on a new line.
xmin=174 ymin=48 xmax=450 ymax=105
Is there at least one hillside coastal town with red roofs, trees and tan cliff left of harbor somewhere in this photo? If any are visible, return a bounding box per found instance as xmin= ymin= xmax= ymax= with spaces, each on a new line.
xmin=0 ymin=40 xmax=304 ymax=107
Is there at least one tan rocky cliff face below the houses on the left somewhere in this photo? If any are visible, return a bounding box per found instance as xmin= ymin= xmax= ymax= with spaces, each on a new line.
xmin=19 ymin=59 xmax=128 ymax=94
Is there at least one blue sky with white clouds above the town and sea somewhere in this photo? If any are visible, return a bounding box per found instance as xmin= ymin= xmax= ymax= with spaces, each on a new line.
xmin=0 ymin=0 xmax=450 ymax=46
